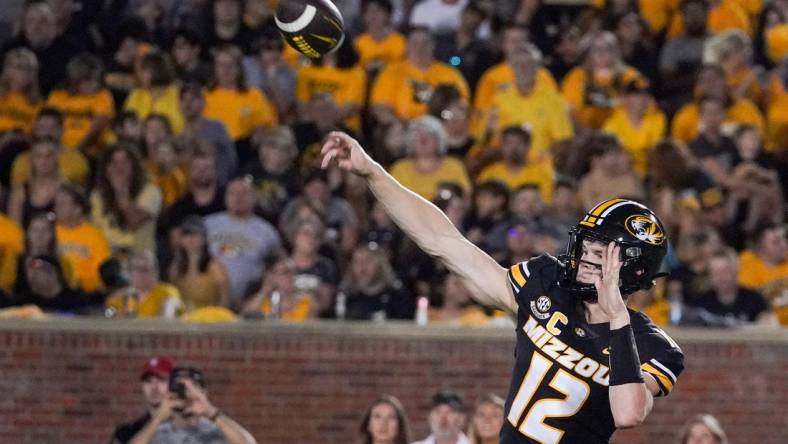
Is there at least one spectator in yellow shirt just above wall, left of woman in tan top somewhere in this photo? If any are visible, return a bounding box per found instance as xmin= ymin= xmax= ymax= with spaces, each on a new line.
xmin=105 ymin=250 xmax=183 ymax=319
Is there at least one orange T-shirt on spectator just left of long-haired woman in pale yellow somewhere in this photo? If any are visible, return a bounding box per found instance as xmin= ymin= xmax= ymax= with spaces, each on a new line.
xmin=55 ymin=223 xmax=110 ymax=291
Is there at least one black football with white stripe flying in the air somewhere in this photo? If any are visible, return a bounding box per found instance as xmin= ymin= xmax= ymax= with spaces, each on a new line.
xmin=274 ymin=0 xmax=345 ymax=58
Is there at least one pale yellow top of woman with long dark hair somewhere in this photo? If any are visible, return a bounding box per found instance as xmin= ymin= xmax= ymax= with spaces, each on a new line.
xmin=90 ymin=183 xmax=162 ymax=251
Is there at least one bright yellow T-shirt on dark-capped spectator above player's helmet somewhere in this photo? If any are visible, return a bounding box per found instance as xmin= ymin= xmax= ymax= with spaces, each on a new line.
xmin=603 ymin=106 xmax=667 ymax=177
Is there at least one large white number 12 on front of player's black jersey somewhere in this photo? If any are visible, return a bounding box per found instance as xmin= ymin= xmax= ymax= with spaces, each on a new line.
xmin=507 ymin=351 xmax=591 ymax=444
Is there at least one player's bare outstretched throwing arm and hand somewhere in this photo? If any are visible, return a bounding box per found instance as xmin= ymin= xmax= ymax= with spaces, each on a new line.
xmin=322 ymin=132 xmax=517 ymax=313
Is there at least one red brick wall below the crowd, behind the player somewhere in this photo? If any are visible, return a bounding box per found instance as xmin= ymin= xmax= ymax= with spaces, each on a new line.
xmin=0 ymin=320 xmax=788 ymax=444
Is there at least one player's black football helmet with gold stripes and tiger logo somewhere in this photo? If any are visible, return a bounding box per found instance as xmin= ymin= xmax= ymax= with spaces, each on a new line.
xmin=559 ymin=199 xmax=668 ymax=302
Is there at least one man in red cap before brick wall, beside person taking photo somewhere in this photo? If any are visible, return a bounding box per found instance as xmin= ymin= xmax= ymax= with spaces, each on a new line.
xmin=110 ymin=356 xmax=175 ymax=444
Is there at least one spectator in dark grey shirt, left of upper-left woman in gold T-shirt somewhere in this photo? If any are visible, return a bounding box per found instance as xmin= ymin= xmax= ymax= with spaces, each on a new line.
xmin=180 ymin=83 xmax=238 ymax=185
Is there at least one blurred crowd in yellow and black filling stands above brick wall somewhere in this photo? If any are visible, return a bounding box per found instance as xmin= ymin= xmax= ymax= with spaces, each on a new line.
xmin=0 ymin=0 xmax=788 ymax=326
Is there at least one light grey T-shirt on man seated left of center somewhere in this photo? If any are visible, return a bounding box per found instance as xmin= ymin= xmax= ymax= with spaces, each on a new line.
xmin=205 ymin=212 xmax=281 ymax=306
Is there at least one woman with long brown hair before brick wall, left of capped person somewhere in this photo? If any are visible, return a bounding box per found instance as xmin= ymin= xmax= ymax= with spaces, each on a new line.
xmin=361 ymin=395 xmax=410 ymax=444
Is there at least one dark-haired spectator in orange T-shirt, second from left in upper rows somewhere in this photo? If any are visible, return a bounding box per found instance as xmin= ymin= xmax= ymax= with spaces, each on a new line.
xmin=46 ymin=53 xmax=115 ymax=157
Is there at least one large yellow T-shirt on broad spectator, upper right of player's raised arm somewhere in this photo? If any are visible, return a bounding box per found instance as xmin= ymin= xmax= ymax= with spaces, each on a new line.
xmin=486 ymin=88 xmax=574 ymax=163
